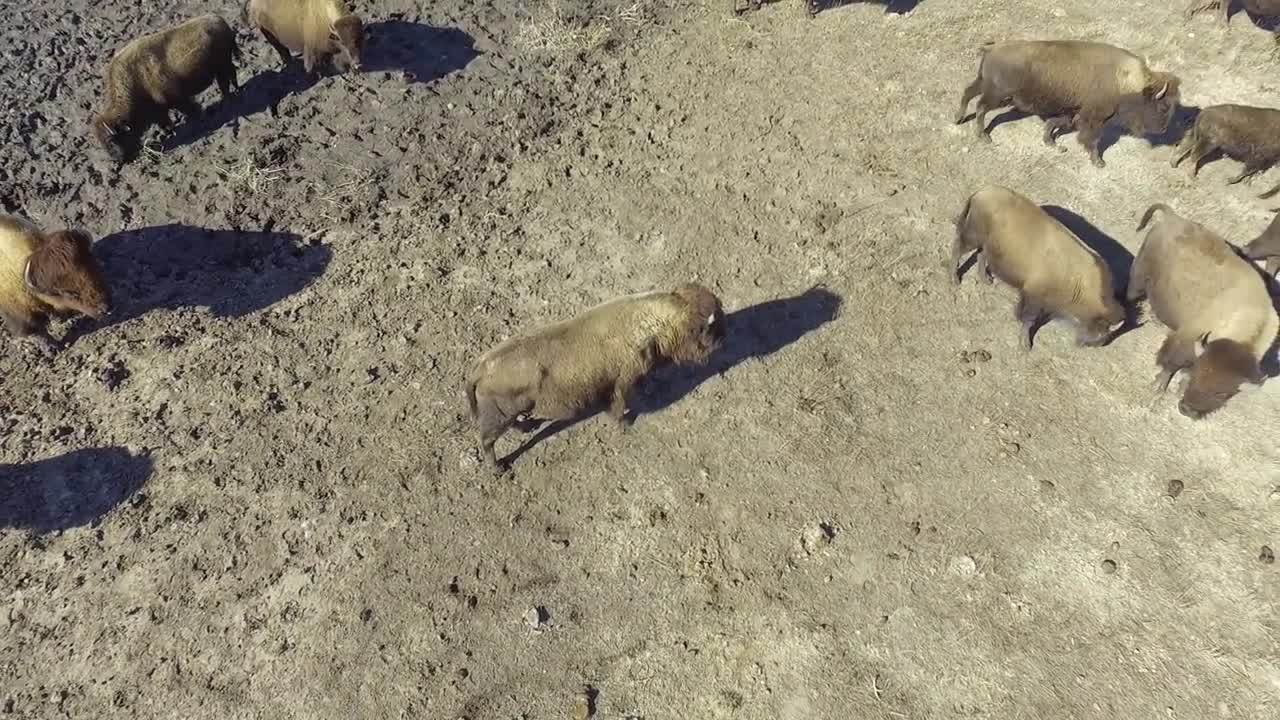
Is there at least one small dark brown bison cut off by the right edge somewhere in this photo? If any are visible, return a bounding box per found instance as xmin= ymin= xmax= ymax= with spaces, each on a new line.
xmin=1170 ymin=105 xmax=1280 ymax=192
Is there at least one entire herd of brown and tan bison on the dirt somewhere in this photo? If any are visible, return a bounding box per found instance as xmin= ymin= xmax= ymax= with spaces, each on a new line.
xmin=0 ymin=0 xmax=1280 ymax=471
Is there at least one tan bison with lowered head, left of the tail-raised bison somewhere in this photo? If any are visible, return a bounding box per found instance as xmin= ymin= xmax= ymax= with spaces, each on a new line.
xmin=950 ymin=187 xmax=1125 ymax=350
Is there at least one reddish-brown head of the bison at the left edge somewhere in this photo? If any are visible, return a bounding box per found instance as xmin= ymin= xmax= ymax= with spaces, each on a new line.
xmin=23 ymin=231 xmax=111 ymax=318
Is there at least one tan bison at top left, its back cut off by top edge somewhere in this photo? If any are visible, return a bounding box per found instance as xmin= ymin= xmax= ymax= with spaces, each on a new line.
xmin=244 ymin=0 xmax=365 ymax=73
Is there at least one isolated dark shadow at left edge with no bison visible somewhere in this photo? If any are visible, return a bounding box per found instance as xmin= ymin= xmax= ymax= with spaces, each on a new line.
xmin=0 ymin=447 xmax=152 ymax=533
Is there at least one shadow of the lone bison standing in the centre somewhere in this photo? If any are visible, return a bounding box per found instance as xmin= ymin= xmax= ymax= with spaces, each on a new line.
xmin=502 ymin=287 xmax=841 ymax=466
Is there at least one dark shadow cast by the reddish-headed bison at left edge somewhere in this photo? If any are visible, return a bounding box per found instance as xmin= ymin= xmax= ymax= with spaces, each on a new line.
xmin=68 ymin=224 xmax=333 ymax=342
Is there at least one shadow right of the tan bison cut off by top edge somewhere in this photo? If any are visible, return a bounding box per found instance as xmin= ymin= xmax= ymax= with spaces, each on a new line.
xmin=364 ymin=19 xmax=480 ymax=82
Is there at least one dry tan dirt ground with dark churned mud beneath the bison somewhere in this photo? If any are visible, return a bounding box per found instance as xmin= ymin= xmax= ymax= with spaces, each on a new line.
xmin=0 ymin=0 xmax=1280 ymax=720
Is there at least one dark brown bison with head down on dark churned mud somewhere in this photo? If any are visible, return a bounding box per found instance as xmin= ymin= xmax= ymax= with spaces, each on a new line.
xmin=93 ymin=15 xmax=239 ymax=163
